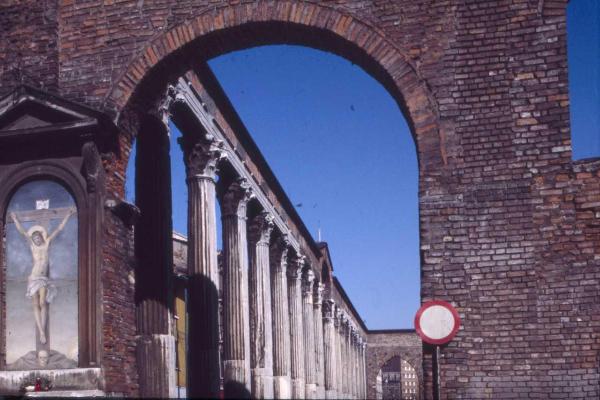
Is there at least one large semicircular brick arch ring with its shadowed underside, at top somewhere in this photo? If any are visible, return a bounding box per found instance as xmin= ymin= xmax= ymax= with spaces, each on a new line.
xmin=104 ymin=0 xmax=446 ymax=169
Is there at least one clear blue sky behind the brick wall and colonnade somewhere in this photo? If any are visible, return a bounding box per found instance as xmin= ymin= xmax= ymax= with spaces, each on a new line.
xmin=128 ymin=0 xmax=600 ymax=329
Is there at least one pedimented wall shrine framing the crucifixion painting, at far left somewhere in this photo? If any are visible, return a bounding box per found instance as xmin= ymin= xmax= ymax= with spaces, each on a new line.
xmin=0 ymin=86 xmax=107 ymax=393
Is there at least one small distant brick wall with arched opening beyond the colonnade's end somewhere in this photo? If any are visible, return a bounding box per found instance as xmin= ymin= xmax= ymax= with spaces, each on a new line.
xmin=367 ymin=348 xmax=424 ymax=399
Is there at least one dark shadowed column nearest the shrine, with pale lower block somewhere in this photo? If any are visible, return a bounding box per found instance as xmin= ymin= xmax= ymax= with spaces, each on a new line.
xmin=135 ymin=111 xmax=176 ymax=397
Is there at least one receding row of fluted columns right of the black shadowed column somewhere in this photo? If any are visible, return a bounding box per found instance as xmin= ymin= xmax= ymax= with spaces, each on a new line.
xmin=181 ymin=130 xmax=366 ymax=399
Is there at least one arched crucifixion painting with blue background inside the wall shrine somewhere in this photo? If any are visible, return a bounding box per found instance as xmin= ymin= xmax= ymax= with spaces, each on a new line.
xmin=5 ymin=180 xmax=78 ymax=370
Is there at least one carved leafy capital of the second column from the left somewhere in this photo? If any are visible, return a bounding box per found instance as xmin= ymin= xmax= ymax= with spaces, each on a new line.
xmin=177 ymin=134 xmax=224 ymax=181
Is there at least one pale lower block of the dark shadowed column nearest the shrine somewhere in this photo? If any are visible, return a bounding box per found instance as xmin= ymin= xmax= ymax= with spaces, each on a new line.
xmin=136 ymin=334 xmax=177 ymax=398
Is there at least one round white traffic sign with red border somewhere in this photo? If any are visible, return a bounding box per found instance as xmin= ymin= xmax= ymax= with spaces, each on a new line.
xmin=415 ymin=300 xmax=460 ymax=345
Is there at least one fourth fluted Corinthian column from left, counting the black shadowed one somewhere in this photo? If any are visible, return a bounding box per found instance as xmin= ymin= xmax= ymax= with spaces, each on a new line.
xmin=248 ymin=213 xmax=273 ymax=399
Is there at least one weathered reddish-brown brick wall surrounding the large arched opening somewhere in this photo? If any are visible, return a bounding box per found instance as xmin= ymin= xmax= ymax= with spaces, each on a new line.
xmin=0 ymin=0 xmax=600 ymax=399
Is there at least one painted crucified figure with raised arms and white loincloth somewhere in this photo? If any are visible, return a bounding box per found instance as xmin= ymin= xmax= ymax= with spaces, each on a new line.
xmin=10 ymin=209 xmax=76 ymax=344
